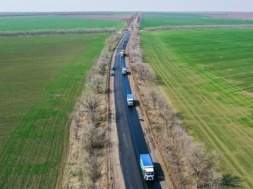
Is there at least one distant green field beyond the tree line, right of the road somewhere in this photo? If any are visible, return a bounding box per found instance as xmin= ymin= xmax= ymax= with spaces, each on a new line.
xmin=140 ymin=13 xmax=253 ymax=29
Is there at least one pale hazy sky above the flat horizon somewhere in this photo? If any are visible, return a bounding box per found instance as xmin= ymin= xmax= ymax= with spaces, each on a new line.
xmin=0 ymin=0 xmax=253 ymax=12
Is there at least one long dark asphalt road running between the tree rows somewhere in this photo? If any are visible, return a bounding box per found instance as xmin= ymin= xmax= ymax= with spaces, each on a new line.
xmin=114 ymin=32 xmax=162 ymax=189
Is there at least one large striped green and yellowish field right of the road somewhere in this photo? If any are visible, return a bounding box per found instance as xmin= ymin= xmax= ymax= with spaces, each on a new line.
xmin=141 ymin=29 xmax=253 ymax=189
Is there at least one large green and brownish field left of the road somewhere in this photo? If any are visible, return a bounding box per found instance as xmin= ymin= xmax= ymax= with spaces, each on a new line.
xmin=0 ymin=34 xmax=109 ymax=189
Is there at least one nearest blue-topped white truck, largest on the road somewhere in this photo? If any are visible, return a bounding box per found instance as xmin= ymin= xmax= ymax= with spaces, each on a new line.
xmin=140 ymin=154 xmax=155 ymax=181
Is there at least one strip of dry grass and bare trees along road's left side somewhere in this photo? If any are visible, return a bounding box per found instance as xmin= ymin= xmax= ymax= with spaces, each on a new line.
xmin=61 ymin=32 xmax=120 ymax=189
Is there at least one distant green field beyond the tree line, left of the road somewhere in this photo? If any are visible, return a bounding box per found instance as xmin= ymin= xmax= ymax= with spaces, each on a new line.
xmin=0 ymin=16 xmax=124 ymax=31
